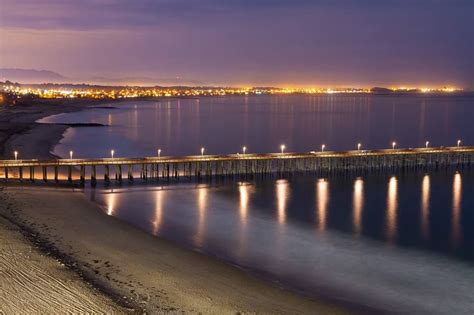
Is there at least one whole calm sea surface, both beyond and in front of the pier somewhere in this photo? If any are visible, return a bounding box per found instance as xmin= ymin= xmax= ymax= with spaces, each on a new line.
xmin=43 ymin=95 xmax=474 ymax=314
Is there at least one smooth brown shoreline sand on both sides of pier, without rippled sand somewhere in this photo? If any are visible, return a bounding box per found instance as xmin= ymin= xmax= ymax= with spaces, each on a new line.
xmin=0 ymin=99 xmax=356 ymax=314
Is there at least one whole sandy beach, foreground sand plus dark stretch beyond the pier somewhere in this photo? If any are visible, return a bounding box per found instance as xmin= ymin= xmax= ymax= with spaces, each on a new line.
xmin=0 ymin=103 xmax=360 ymax=314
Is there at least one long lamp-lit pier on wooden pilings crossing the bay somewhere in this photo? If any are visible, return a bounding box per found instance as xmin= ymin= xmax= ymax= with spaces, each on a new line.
xmin=0 ymin=146 xmax=474 ymax=186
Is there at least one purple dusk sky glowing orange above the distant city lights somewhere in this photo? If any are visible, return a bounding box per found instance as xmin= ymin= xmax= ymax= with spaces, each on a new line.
xmin=0 ymin=0 xmax=474 ymax=88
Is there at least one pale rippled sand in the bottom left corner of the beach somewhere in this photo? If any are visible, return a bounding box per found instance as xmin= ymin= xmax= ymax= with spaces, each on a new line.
xmin=0 ymin=209 xmax=129 ymax=314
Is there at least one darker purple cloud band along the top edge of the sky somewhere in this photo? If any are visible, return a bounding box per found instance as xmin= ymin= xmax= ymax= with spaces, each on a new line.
xmin=0 ymin=0 xmax=473 ymax=30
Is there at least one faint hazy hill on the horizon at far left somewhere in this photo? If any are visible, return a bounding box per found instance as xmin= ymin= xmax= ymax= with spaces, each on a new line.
xmin=0 ymin=69 xmax=68 ymax=83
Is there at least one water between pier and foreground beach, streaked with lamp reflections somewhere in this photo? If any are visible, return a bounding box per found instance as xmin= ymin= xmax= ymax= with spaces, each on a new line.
xmin=91 ymin=172 xmax=474 ymax=313
